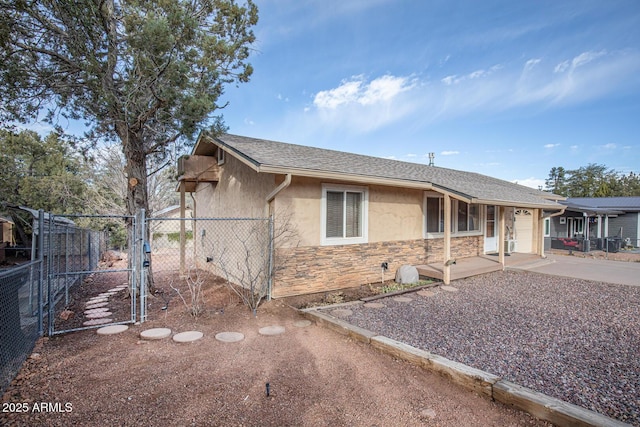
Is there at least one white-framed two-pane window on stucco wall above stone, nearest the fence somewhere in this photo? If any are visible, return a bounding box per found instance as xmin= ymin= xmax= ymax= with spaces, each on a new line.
xmin=322 ymin=185 xmax=368 ymax=245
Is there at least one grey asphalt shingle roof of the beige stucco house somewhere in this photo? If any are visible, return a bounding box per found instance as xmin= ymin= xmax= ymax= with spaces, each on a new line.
xmin=202 ymin=134 xmax=559 ymax=209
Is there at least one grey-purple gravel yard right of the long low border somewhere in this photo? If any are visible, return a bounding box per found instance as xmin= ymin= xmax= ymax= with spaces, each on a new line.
xmin=340 ymin=271 xmax=640 ymax=426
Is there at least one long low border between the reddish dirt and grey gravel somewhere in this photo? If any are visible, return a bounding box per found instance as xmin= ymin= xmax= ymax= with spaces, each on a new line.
xmin=300 ymin=304 xmax=629 ymax=427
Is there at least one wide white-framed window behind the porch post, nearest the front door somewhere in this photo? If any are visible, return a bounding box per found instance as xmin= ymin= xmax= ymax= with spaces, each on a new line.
xmin=425 ymin=196 xmax=480 ymax=234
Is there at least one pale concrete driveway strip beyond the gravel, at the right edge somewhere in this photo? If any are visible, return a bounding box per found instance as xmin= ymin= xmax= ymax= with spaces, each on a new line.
xmin=507 ymin=254 xmax=640 ymax=286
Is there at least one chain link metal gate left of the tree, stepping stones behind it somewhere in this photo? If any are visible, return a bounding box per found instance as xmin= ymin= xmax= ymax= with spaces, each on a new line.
xmin=45 ymin=215 xmax=142 ymax=336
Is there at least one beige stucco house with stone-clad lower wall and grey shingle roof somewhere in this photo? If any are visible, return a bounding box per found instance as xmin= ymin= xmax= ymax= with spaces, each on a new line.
xmin=179 ymin=135 xmax=564 ymax=297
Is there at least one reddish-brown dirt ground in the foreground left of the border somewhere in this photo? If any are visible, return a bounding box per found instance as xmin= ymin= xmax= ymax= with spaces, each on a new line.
xmin=0 ymin=262 xmax=548 ymax=426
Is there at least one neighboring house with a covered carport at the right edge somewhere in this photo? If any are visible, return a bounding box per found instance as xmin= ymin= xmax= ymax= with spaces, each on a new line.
xmin=545 ymin=197 xmax=640 ymax=251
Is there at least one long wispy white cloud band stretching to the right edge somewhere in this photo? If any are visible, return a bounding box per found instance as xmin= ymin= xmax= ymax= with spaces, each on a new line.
xmin=291 ymin=49 xmax=640 ymax=136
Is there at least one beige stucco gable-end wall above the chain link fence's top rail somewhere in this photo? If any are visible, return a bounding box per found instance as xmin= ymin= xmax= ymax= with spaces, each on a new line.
xmin=195 ymin=156 xmax=276 ymax=218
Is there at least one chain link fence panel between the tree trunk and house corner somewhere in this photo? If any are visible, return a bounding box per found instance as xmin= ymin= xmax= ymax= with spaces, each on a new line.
xmin=147 ymin=218 xmax=273 ymax=314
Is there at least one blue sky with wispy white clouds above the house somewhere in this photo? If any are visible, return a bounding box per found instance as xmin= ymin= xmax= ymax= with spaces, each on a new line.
xmin=222 ymin=0 xmax=640 ymax=187
